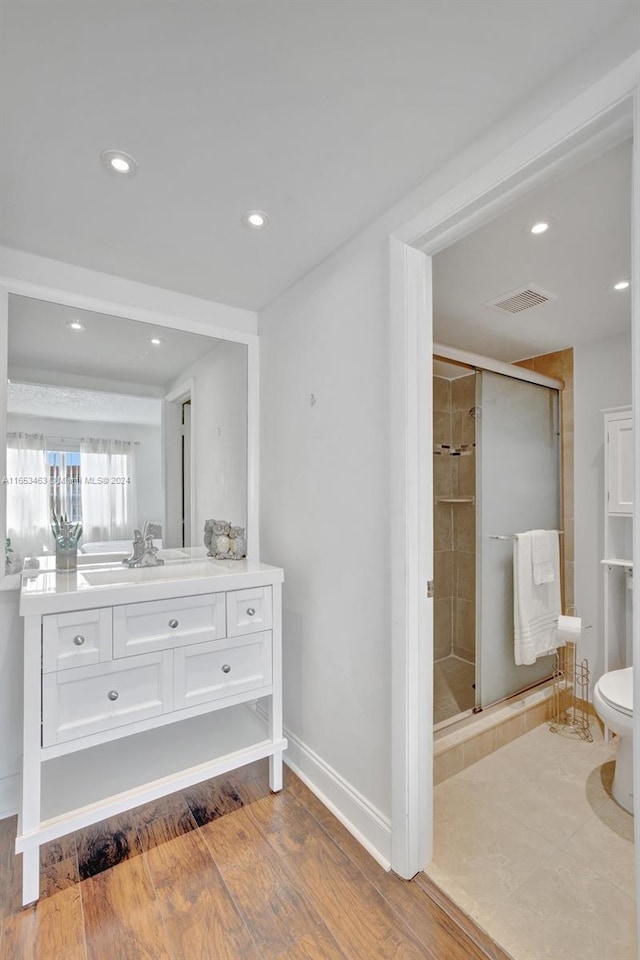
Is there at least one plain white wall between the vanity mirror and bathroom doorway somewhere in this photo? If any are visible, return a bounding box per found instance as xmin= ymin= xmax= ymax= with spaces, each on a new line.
xmin=260 ymin=236 xmax=391 ymax=829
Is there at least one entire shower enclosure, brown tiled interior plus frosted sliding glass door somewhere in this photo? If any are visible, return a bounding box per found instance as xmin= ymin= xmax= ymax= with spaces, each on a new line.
xmin=433 ymin=364 xmax=560 ymax=726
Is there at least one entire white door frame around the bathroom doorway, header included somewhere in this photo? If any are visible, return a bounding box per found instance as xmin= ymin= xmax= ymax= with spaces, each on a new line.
xmin=389 ymin=52 xmax=640 ymax=880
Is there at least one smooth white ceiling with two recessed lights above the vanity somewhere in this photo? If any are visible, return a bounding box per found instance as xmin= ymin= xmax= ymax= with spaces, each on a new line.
xmin=0 ymin=0 xmax=636 ymax=309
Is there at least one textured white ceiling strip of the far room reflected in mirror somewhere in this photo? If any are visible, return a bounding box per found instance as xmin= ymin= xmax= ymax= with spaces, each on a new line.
xmin=7 ymin=382 xmax=161 ymax=426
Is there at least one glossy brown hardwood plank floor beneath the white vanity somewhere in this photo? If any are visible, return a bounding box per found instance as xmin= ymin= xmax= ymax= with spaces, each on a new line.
xmin=0 ymin=761 xmax=506 ymax=960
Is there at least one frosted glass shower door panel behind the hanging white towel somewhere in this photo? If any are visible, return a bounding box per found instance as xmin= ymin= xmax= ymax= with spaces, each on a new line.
xmin=476 ymin=370 xmax=560 ymax=707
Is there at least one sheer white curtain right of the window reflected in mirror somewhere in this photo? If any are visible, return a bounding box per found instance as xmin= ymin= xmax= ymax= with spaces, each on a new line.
xmin=80 ymin=438 xmax=138 ymax=543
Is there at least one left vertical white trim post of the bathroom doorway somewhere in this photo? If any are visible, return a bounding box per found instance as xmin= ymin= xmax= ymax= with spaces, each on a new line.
xmin=389 ymin=237 xmax=433 ymax=879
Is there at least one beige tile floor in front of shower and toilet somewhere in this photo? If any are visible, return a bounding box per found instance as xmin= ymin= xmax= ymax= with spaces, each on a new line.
xmin=426 ymin=720 xmax=636 ymax=960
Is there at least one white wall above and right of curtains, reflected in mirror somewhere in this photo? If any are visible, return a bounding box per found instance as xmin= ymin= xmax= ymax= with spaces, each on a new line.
xmin=7 ymin=412 xmax=164 ymax=537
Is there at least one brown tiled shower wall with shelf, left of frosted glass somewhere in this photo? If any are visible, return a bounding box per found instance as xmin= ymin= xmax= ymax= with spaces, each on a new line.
xmin=433 ymin=374 xmax=476 ymax=662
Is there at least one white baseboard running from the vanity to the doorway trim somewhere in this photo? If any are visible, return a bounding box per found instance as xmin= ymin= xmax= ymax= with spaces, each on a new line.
xmin=258 ymin=704 xmax=391 ymax=870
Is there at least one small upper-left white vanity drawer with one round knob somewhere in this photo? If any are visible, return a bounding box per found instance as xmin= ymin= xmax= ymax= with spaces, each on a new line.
xmin=42 ymin=607 xmax=111 ymax=673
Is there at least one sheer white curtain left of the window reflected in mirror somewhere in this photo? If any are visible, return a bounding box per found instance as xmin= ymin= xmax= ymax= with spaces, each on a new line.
xmin=5 ymin=433 xmax=54 ymax=560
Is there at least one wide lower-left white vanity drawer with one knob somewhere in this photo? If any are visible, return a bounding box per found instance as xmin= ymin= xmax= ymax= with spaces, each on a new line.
xmin=42 ymin=653 xmax=173 ymax=747
